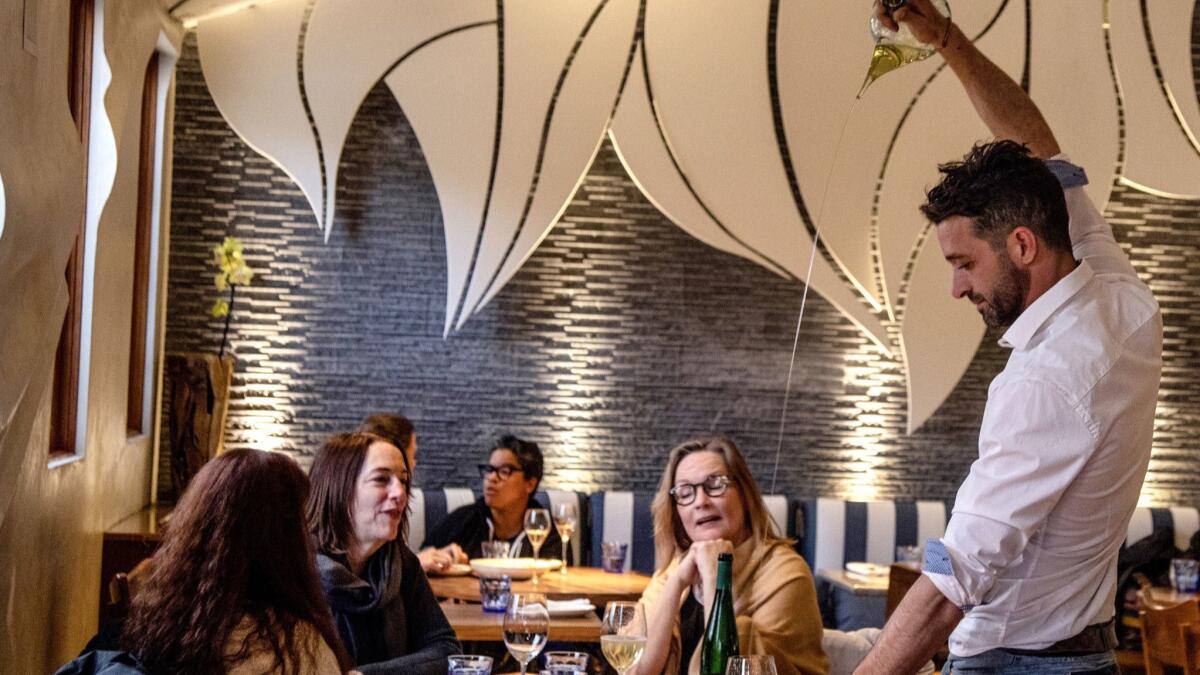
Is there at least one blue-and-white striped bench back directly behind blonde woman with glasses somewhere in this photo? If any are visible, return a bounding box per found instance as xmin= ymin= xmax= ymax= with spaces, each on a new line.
xmin=589 ymin=490 xmax=796 ymax=574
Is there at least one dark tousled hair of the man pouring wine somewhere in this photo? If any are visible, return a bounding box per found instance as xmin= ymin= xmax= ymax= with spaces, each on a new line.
xmin=920 ymin=141 xmax=1070 ymax=252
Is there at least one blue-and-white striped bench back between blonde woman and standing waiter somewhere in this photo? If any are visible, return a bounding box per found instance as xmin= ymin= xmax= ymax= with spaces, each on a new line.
xmin=800 ymin=498 xmax=947 ymax=572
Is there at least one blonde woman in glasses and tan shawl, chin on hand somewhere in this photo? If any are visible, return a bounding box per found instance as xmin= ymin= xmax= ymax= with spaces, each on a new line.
xmin=634 ymin=437 xmax=828 ymax=675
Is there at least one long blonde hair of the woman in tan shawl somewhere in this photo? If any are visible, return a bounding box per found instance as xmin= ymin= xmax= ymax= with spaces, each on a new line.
xmin=650 ymin=436 xmax=786 ymax=571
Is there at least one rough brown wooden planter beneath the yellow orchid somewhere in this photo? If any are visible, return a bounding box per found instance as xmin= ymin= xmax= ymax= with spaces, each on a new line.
xmin=166 ymin=352 xmax=233 ymax=500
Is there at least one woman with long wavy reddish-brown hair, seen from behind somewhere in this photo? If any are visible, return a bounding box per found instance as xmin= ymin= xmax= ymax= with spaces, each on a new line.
xmin=122 ymin=450 xmax=352 ymax=675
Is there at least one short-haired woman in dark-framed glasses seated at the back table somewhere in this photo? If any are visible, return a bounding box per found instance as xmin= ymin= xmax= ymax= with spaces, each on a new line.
xmin=425 ymin=435 xmax=563 ymax=560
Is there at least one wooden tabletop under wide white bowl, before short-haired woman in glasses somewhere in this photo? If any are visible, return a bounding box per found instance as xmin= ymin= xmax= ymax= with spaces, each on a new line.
xmin=430 ymin=567 xmax=650 ymax=610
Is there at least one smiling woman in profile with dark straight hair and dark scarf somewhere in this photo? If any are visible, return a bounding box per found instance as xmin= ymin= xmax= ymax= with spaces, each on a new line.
xmin=308 ymin=432 xmax=461 ymax=675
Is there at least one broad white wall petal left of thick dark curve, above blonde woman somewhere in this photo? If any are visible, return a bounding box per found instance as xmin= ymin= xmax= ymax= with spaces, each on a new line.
xmin=611 ymin=2 xmax=890 ymax=352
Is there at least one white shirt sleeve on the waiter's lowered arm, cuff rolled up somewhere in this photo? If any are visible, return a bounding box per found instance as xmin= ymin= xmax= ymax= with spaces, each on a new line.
xmin=924 ymin=378 xmax=1096 ymax=611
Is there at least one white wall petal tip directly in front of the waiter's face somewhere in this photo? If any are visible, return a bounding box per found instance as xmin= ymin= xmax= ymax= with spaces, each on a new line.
xmin=900 ymin=232 xmax=984 ymax=434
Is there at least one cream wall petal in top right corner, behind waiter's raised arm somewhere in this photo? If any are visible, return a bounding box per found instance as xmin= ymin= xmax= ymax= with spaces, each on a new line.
xmin=1106 ymin=1 xmax=1200 ymax=198
